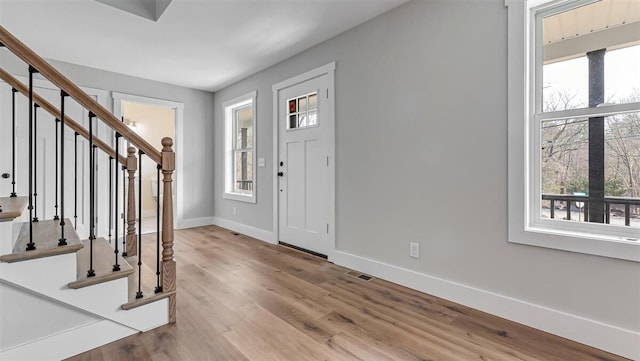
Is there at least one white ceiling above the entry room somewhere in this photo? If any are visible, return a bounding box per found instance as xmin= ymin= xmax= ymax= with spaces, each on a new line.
xmin=0 ymin=0 xmax=407 ymax=91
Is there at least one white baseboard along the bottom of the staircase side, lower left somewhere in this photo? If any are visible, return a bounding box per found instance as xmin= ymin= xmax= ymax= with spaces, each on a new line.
xmin=0 ymin=320 xmax=138 ymax=361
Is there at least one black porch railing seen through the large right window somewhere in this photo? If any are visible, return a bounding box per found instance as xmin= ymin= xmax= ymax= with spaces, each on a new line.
xmin=542 ymin=194 xmax=640 ymax=226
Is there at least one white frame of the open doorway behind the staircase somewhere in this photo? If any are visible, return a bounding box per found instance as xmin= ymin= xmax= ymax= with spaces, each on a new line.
xmin=111 ymin=92 xmax=184 ymax=228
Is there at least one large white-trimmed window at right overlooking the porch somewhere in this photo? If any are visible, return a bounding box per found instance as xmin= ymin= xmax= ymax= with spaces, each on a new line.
xmin=507 ymin=0 xmax=640 ymax=261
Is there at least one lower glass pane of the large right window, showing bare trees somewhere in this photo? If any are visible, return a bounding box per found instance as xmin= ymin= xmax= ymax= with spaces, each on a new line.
xmin=540 ymin=112 xmax=640 ymax=227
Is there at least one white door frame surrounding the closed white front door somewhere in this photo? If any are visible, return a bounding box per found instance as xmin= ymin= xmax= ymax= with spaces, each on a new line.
xmin=272 ymin=62 xmax=336 ymax=261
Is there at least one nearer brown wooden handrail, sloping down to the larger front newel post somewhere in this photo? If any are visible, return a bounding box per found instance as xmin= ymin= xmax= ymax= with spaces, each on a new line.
xmin=0 ymin=26 xmax=162 ymax=164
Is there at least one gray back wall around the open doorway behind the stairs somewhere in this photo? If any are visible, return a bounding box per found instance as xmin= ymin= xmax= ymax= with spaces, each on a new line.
xmin=0 ymin=52 xmax=214 ymax=220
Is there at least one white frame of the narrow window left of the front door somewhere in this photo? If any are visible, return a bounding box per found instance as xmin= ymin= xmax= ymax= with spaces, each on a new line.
xmin=222 ymin=91 xmax=257 ymax=203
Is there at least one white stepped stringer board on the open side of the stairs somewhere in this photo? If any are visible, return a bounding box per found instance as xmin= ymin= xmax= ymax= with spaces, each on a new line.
xmin=0 ymin=253 xmax=169 ymax=332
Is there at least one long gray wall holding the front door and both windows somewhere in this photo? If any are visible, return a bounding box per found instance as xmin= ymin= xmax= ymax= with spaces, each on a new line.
xmin=213 ymin=0 xmax=640 ymax=331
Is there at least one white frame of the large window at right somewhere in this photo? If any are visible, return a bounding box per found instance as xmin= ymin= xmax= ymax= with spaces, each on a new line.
xmin=505 ymin=0 xmax=640 ymax=262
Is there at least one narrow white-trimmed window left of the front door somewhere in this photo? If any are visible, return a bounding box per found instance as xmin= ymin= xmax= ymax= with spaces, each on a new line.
xmin=223 ymin=92 xmax=256 ymax=203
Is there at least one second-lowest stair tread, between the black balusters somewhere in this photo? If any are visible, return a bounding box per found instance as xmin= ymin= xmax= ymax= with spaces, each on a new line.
xmin=69 ymin=237 xmax=133 ymax=289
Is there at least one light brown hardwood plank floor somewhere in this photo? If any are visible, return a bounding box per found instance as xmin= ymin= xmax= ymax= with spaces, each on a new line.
xmin=67 ymin=226 xmax=625 ymax=361
